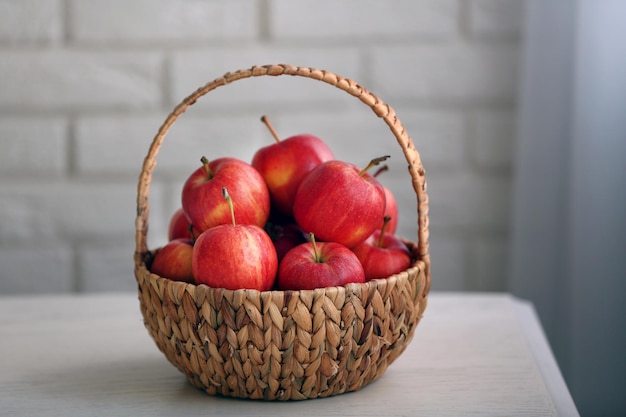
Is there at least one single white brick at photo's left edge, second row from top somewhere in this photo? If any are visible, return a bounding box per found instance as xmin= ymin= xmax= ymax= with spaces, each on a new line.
xmin=0 ymin=48 xmax=163 ymax=109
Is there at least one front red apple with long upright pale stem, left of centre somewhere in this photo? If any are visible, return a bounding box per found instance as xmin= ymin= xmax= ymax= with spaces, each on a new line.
xmin=191 ymin=188 xmax=278 ymax=291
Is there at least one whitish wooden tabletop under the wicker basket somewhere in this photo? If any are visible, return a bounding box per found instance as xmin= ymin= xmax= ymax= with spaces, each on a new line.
xmin=0 ymin=293 xmax=578 ymax=417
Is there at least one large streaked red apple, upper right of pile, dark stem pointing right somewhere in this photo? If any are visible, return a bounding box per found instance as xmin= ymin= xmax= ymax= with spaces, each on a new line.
xmin=293 ymin=157 xmax=387 ymax=248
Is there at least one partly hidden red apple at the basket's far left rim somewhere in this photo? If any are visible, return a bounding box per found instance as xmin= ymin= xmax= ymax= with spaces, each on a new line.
xmin=150 ymin=239 xmax=194 ymax=283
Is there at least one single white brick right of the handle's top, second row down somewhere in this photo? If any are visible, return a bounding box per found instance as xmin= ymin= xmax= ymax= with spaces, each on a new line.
xmin=371 ymin=42 xmax=518 ymax=105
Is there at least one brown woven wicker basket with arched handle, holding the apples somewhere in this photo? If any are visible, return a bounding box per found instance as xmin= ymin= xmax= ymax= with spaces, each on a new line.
xmin=134 ymin=65 xmax=430 ymax=400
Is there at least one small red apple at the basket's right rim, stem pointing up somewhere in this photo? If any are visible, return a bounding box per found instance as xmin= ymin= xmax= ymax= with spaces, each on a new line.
xmin=352 ymin=217 xmax=411 ymax=281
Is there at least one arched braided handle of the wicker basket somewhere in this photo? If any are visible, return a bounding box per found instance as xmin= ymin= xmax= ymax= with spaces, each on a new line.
xmin=135 ymin=65 xmax=430 ymax=281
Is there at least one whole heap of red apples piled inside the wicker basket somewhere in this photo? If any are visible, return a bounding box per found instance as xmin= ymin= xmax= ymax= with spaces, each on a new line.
xmin=150 ymin=116 xmax=412 ymax=291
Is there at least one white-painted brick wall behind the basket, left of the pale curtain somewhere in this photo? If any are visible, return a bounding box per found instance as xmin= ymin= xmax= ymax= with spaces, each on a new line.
xmin=0 ymin=0 xmax=523 ymax=294
